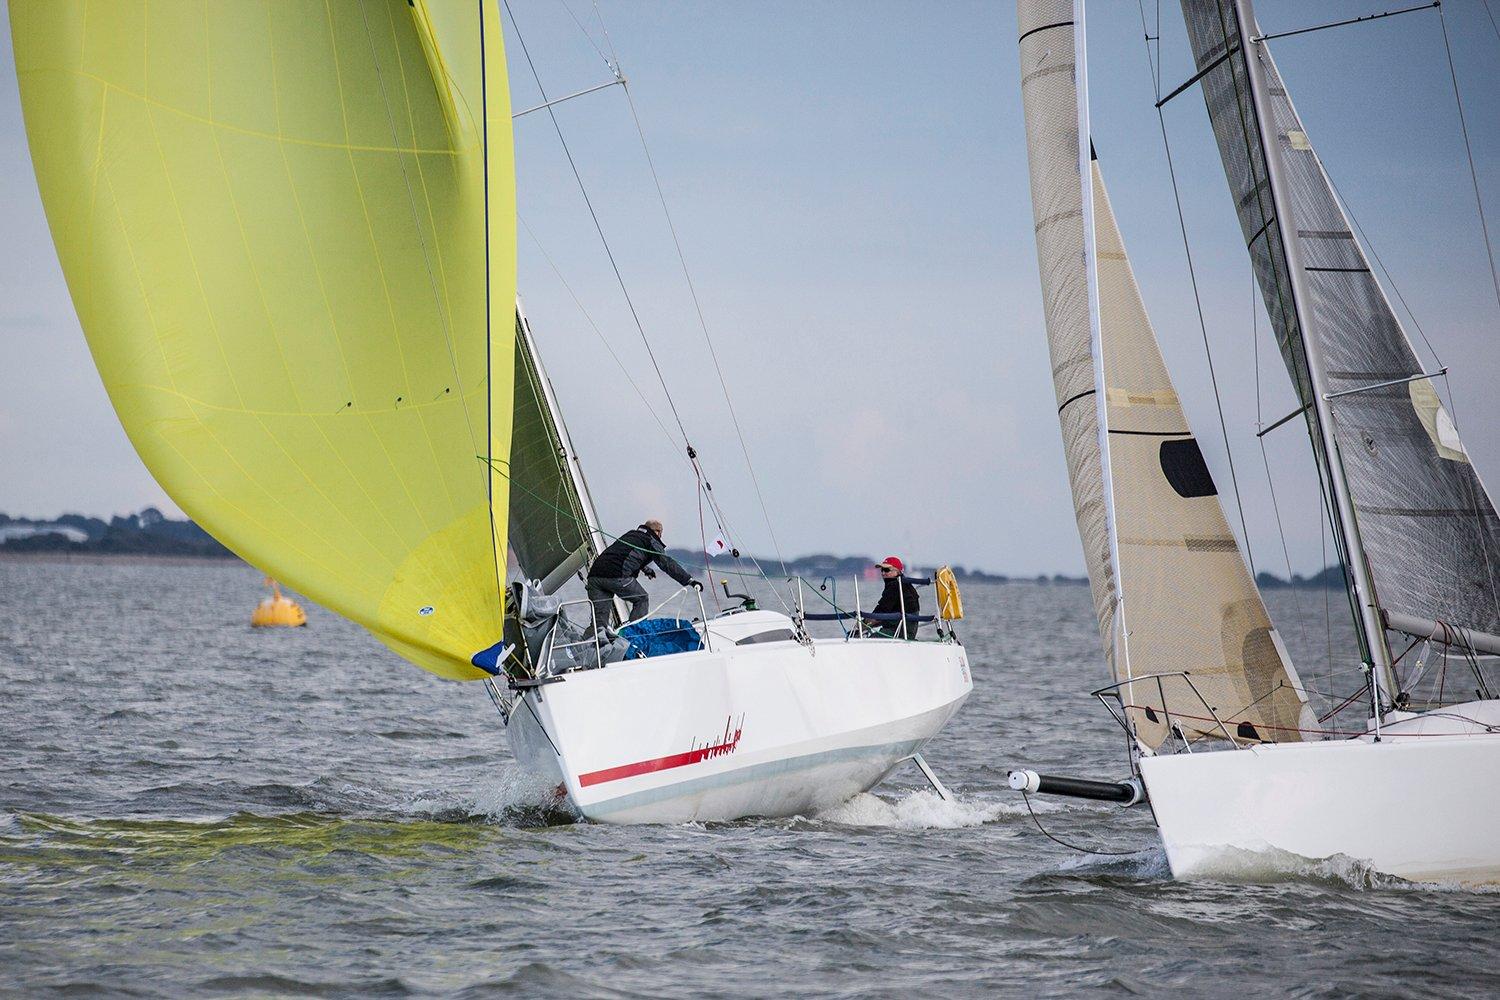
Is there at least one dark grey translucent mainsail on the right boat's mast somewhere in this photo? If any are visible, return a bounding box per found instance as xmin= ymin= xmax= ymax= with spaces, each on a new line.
xmin=1182 ymin=0 xmax=1500 ymax=644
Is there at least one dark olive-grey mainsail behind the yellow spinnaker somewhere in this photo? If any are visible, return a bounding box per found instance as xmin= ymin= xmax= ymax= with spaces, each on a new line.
xmin=510 ymin=309 xmax=597 ymax=594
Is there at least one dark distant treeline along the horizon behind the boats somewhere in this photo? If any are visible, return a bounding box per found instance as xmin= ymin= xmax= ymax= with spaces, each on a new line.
xmin=0 ymin=507 xmax=1344 ymax=591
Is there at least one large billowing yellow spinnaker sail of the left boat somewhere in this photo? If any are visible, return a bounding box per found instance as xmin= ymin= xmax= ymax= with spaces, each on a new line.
xmin=11 ymin=0 xmax=516 ymax=679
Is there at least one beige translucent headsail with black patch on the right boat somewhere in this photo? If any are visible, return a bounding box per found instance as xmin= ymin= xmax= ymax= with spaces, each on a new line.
xmin=1019 ymin=0 xmax=1307 ymax=748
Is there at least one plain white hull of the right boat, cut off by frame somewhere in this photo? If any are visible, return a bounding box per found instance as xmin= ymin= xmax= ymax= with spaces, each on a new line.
xmin=1140 ymin=702 xmax=1500 ymax=885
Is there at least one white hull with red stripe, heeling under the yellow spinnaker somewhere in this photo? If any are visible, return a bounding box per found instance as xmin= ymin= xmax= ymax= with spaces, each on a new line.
xmin=507 ymin=639 xmax=972 ymax=823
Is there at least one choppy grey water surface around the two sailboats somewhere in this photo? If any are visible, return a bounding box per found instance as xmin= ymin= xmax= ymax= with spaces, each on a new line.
xmin=0 ymin=561 xmax=1500 ymax=997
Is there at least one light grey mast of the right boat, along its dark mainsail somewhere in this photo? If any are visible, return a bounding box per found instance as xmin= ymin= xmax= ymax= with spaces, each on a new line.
xmin=1233 ymin=0 xmax=1397 ymax=710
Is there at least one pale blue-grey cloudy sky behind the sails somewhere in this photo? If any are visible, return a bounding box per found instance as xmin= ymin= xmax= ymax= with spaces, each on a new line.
xmin=0 ymin=0 xmax=1500 ymax=574
